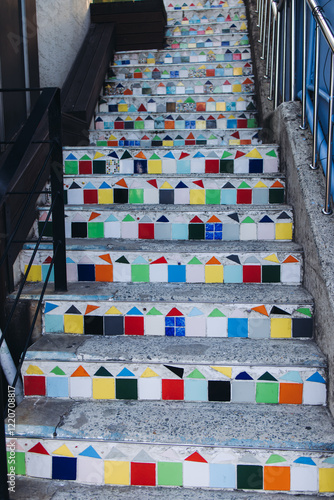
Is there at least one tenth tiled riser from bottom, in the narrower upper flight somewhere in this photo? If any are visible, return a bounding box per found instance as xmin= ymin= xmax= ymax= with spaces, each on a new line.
xmin=99 ymin=94 xmax=255 ymax=112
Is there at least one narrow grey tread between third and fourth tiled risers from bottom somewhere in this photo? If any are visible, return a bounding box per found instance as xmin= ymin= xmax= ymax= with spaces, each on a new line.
xmin=21 ymin=282 xmax=313 ymax=300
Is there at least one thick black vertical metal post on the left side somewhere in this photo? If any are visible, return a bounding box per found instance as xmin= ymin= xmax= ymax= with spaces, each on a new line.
xmin=49 ymin=89 xmax=67 ymax=292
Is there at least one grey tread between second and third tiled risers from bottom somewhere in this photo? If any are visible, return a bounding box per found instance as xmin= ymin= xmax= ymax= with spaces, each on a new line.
xmin=26 ymin=334 xmax=326 ymax=369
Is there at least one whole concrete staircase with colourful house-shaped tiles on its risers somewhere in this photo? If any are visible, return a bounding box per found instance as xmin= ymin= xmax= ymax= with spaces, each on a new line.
xmin=8 ymin=0 xmax=334 ymax=498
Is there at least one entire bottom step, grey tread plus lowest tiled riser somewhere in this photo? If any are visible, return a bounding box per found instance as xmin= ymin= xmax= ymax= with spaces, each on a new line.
xmin=7 ymin=398 xmax=334 ymax=493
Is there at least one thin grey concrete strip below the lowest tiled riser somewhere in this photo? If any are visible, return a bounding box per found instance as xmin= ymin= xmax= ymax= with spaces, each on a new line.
xmin=10 ymin=477 xmax=319 ymax=500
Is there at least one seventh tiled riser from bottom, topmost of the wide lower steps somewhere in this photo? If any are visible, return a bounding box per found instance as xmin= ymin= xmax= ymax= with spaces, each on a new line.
xmin=63 ymin=144 xmax=279 ymax=176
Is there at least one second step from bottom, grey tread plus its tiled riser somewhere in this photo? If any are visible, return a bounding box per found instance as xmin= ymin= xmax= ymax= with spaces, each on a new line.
xmin=22 ymin=334 xmax=326 ymax=405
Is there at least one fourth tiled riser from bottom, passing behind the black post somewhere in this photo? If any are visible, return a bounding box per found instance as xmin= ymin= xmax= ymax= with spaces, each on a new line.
xmin=20 ymin=248 xmax=302 ymax=285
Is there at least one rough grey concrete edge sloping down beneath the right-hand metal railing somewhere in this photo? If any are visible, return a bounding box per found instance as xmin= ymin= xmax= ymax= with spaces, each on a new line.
xmin=248 ymin=0 xmax=334 ymax=415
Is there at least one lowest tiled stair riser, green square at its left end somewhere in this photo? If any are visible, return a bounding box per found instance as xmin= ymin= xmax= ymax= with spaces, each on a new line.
xmin=7 ymin=438 xmax=334 ymax=495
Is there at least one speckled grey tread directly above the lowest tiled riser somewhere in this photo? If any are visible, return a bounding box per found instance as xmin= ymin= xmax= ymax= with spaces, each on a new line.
xmin=11 ymin=398 xmax=334 ymax=452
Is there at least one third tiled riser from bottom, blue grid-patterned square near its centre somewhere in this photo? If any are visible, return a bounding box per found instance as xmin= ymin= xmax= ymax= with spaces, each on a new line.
xmin=43 ymin=298 xmax=313 ymax=339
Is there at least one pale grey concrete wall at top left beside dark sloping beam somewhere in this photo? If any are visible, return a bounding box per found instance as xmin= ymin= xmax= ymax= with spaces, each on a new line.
xmin=36 ymin=0 xmax=90 ymax=87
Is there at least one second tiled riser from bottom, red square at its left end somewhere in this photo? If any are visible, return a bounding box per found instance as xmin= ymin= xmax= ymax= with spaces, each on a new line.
xmin=22 ymin=360 xmax=326 ymax=405
